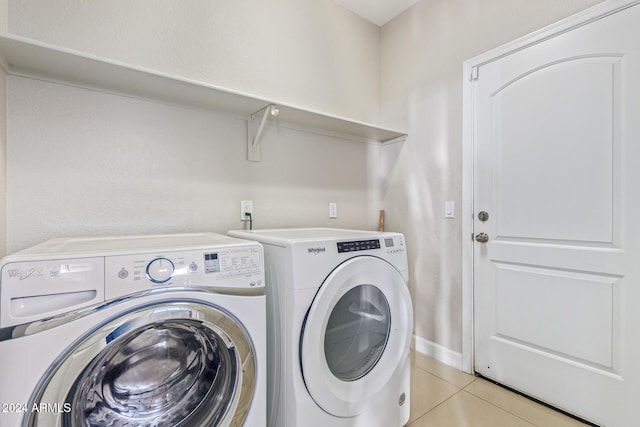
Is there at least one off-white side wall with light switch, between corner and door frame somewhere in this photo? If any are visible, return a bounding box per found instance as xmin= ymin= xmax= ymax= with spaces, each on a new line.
xmin=381 ymin=0 xmax=600 ymax=352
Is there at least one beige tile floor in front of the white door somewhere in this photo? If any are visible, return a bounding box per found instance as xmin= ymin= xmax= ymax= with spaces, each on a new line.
xmin=406 ymin=351 xmax=586 ymax=427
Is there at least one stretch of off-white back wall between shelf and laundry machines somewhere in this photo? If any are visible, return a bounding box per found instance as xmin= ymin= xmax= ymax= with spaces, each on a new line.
xmin=7 ymin=76 xmax=380 ymax=252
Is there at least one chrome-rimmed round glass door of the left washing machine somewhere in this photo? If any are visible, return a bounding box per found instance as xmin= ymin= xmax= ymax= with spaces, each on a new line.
xmin=27 ymin=302 xmax=255 ymax=427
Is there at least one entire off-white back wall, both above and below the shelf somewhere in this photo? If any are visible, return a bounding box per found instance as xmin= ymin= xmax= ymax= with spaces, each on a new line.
xmin=5 ymin=0 xmax=381 ymax=252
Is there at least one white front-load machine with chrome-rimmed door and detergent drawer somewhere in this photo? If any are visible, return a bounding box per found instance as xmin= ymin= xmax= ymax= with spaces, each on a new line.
xmin=0 ymin=233 xmax=266 ymax=427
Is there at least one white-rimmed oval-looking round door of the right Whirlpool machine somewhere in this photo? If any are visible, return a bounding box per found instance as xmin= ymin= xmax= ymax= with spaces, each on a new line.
xmin=300 ymin=256 xmax=413 ymax=417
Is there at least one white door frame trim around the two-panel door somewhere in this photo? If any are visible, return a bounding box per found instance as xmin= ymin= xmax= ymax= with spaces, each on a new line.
xmin=461 ymin=0 xmax=640 ymax=373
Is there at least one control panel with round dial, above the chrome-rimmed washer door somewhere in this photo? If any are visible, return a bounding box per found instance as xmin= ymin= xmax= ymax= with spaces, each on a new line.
xmin=105 ymin=245 xmax=264 ymax=300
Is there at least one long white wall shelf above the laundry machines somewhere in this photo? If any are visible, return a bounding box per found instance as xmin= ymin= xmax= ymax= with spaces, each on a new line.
xmin=0 ymin=33 xmax=406 ymax=142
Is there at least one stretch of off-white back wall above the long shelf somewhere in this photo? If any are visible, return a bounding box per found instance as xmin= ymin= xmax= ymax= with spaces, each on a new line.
xmin=4 ymin=0 xmax=380 ymax=123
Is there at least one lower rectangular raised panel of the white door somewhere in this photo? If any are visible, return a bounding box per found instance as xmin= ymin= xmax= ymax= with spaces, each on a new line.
xmin=495 ymin=263 xmax=622 ymax=373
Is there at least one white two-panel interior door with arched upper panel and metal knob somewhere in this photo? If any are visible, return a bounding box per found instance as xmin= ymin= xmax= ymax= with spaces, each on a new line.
xmin=473 ymin=5 xmax=640 ymax=426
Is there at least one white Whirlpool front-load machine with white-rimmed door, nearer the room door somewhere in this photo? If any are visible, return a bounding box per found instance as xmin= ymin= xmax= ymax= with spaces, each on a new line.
xmin=229 ymin=228 xmax=413 ymax=427
